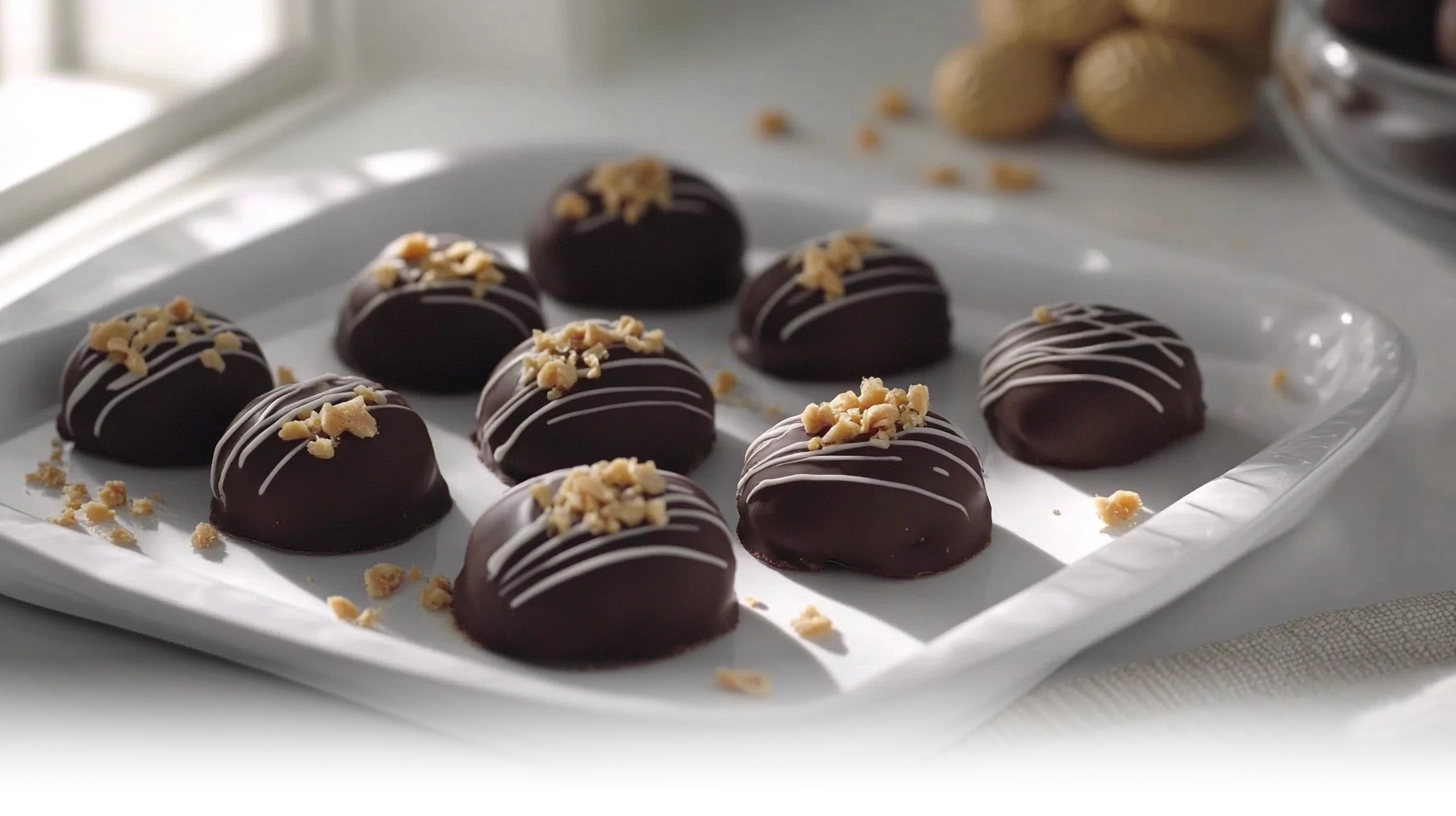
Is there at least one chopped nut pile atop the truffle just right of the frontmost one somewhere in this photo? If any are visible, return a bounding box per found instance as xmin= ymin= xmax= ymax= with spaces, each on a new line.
xmin=799 ymin=377 xmax=930 ymax=450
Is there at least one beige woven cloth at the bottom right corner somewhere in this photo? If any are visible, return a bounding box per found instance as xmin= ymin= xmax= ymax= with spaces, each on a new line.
xmin=796 ymin=592 xmax=1456 ymax=799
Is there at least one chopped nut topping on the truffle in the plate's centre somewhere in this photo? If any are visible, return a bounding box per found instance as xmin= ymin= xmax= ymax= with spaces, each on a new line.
xmin=521 ymin=315 xmax=665 ymax=399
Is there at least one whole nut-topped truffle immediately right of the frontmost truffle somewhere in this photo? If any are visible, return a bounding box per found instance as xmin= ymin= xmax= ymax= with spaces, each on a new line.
xmin=737 ymin=377 xmax=992 ymax=578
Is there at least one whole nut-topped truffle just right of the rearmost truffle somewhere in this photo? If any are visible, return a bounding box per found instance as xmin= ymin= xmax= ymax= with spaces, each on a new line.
xmin=734 ymin=230 xmax=951 ymax=380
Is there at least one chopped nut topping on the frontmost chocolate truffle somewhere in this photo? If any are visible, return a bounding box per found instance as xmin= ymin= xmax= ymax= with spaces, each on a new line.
xmin=531 ymin=459 xmax=667 ymax=535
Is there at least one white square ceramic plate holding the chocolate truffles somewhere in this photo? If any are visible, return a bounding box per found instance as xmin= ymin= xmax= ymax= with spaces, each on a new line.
xmin=0 ymin=146 xmax=1414 ymax=788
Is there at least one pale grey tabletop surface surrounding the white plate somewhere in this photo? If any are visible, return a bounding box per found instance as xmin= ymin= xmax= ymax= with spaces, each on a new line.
xmin=0 ymin=0 xmax=1456 ymax=799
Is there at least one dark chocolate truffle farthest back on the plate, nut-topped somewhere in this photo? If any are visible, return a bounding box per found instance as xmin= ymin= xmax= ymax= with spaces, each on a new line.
xmin=527 ymin=157 xmax=747 ymax=309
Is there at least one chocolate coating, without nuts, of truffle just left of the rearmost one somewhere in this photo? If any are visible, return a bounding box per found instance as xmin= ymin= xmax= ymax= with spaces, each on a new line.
xmin=333 ymin=233 xmax=546 ymax=393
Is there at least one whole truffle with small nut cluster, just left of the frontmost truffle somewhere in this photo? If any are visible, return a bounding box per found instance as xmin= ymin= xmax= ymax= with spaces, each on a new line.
xmin=210 ymin=374 xmax=451 ymax=554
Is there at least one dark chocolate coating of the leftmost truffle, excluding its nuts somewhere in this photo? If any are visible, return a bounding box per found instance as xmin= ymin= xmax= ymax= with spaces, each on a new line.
xmin=55 ymin=309 xmax=274 ymax=468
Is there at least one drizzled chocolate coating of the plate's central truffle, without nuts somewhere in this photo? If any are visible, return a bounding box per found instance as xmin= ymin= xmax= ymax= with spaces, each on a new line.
xmin=475 ymin=327 xmax=718 ymax=484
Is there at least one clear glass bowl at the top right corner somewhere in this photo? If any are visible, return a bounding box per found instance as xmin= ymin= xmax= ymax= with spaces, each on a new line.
xmin=1270 ymin=0 xmax=1456 ymax=254
